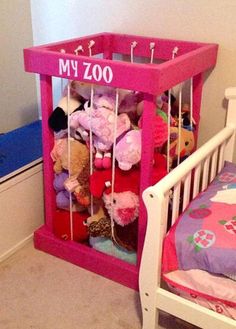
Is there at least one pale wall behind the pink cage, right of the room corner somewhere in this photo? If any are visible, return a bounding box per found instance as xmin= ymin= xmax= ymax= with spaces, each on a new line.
xmin=31 ymin=0 xmax=236 ymax=155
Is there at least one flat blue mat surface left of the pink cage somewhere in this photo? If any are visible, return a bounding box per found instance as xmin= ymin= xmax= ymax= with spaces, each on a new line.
xmin=0 ymin=120 xmax=42 ymax=178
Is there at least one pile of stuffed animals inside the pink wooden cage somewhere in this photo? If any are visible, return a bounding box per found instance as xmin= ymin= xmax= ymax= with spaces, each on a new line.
xmin=48 ymin=81 xmax=194 ymax=262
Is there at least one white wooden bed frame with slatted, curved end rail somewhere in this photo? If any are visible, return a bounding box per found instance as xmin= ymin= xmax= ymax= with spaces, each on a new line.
xmin=139 ymin=88 xmax=236 ymax=329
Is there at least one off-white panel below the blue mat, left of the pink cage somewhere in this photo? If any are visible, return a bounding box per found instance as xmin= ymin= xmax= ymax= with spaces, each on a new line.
xmin=0 ymin=163 xmax=44 ymax=262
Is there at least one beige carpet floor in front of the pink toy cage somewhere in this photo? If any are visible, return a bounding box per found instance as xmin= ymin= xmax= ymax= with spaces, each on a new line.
xmin=0 ymin=243 xmax=197 ymax=329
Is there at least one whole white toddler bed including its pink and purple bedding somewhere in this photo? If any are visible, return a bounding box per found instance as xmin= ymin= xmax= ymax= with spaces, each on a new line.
xmin=139 ymin=88 xmax=236 ymax=329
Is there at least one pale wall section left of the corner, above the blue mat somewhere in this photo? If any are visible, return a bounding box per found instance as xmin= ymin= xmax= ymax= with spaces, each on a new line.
xmin=0 ymin=0 xmax=38 ymax=133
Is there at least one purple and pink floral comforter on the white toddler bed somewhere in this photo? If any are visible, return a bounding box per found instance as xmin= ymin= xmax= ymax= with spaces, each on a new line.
xmin=162 ymin=162 xmax=236 ymax=276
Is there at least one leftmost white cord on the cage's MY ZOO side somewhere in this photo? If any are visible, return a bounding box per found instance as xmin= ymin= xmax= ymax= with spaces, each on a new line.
xmin=67 ymin=80 xmax=74 ymax=240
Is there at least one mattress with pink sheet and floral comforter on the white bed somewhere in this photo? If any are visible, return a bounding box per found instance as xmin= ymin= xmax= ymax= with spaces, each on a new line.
xmin=162 ymin=162 xmax=236 ymax=319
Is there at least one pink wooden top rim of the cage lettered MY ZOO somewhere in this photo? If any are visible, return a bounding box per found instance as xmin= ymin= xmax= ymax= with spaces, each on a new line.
xmin=24 ymin=34 xmax=217 ymax=95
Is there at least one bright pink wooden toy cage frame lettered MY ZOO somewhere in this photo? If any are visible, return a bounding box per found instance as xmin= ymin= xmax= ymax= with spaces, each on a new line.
xmin=24 ymin=33 xmax=217 ymax=289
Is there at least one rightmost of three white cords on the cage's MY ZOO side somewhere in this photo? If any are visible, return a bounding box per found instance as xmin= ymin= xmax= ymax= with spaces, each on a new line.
xmin=111 ymin=89 xmax=119 ymax=240
